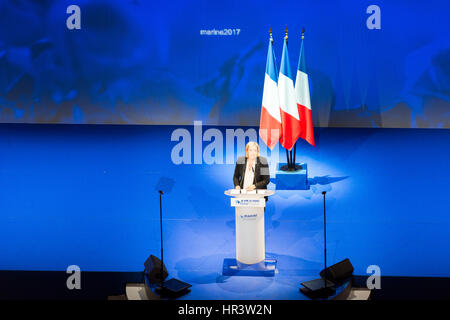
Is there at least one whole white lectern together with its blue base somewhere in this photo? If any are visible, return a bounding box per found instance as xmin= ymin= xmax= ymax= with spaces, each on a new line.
xmin=222 ymin=189 xmax=276 ymax=277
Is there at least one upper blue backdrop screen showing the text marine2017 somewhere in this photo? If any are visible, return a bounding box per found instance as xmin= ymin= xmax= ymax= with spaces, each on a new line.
xmin=0 ymin=0 xmax=450 ymax=128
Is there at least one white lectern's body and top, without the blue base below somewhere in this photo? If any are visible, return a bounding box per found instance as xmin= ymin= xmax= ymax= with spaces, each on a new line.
xmin=225 ymin=190 xmax=274 ymax=264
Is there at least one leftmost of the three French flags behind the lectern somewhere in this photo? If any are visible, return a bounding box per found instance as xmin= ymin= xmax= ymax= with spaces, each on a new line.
xmin=259 ymin=39 xmax=281 ymax=150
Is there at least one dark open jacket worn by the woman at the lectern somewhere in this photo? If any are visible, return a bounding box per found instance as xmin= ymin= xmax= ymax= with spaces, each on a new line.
xmin=233 ymin=156 xmax=270 ymax=189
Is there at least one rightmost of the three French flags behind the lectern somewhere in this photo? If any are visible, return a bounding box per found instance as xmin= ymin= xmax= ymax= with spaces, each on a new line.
xmin=295 ymin=36 xmax=316 ymax=146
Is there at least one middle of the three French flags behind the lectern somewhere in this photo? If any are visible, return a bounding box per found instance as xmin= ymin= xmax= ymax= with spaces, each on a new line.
xmin=278 ymin=36 xmax=300 ymax=150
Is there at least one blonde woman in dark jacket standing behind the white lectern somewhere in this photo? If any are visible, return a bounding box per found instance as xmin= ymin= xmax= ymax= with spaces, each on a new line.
xmin=233 ymin=141 xmax=270 ymax=192
